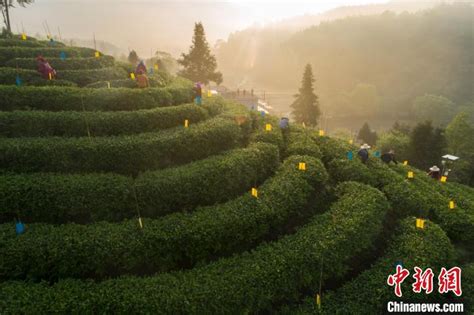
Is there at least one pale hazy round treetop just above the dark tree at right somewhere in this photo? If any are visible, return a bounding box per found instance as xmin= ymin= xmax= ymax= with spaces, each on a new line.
xmin=412 ymin=94 xmax=454 ymax=126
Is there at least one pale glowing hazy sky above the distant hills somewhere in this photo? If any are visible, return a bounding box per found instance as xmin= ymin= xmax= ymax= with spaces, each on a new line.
xmin=11 ymin=0 xmax=388 ymax=55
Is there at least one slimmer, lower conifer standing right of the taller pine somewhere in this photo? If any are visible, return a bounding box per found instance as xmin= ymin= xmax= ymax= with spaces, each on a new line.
xmin=291 ymin=64 xmax=321 ymax=126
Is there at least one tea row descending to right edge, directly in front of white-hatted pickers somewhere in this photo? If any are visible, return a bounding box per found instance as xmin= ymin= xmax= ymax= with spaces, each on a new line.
xmin=316 ymin=137 xmax=474 ymax=244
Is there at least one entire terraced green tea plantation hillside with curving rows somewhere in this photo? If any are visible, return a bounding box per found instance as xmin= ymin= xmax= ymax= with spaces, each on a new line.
xmin=0 ymin=38 xmax=474 ymax=314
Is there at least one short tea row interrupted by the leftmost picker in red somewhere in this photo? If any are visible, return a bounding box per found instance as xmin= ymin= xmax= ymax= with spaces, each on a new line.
xmin=5 ymin=56 xmax=114 ymax=71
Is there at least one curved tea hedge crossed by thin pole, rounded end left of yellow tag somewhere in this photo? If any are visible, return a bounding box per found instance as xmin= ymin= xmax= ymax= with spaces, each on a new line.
xmin=0 ymin=143 xmax=279 ymax=223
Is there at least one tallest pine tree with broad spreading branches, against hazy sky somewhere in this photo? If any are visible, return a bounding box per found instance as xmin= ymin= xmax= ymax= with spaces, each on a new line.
xmin=178 ymin=22 xmax=222 ymax=85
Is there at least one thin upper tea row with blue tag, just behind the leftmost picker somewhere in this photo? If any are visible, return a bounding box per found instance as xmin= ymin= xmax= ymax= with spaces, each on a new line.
xmin=0 ymin=47 xmax=95 ymax=66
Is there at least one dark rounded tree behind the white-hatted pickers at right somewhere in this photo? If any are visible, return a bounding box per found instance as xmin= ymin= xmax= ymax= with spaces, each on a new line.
xmin=409 ymin=121 xmax=446 ymax=169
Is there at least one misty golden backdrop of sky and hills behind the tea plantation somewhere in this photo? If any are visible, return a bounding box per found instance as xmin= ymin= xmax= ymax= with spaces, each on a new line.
xmin=12 ymin=0 xmax=474 ymax=131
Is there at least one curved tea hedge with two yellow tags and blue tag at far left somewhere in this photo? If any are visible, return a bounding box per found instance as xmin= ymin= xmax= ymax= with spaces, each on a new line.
xmin=0 ymin=156 xmax=327 ymax=279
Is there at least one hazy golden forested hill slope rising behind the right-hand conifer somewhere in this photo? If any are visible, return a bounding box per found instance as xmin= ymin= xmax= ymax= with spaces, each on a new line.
xmin=217 ymin=3 xmax=474 ymax=124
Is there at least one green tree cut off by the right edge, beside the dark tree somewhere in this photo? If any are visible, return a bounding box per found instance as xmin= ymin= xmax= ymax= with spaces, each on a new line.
xmin=446 ymin=112 xmax=474 ymax=185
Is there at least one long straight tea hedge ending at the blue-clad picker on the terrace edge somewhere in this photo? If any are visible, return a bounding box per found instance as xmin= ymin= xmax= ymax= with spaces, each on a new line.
xmin=0 ymin=85 xmax=192 ymax=111
